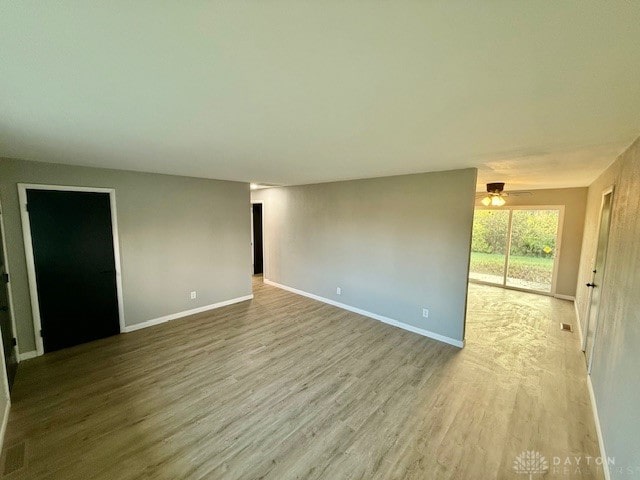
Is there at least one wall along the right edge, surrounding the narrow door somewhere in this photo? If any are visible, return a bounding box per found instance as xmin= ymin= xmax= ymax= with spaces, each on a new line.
xmin=578 ymin=139 xmax=640 ymax=478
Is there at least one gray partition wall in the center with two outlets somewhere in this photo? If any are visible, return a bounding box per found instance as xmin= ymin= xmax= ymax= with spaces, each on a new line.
xmin=252 ymin=169 xmax=476 ymax=340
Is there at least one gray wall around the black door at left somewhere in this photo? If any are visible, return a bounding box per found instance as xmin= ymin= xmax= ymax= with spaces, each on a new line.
xmin=0 ymin=159 xmax=251 ymax=352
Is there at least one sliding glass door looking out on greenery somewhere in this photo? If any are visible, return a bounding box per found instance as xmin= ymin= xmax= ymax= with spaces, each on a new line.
xmin=469 ymin=207 xmax=560 ymax=293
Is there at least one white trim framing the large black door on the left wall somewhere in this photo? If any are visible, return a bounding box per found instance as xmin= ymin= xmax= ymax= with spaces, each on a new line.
xmin=18 ymin=183 xmax=125 ymax=355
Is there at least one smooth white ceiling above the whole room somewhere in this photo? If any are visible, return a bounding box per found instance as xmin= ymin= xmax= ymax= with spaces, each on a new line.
xmin=0 ymin=0 xmax=640 ymax=189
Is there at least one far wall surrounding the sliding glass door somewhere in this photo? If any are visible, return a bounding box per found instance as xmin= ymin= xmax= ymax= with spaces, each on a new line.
xmin=476 ymin=187 xmax=588 ymax=297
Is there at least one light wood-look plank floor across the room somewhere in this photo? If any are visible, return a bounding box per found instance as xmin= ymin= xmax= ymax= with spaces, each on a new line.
xmin=2 ymin=281 xmax=601 ymax=480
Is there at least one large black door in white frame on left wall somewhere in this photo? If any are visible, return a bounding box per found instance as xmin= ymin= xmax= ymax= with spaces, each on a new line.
xmin=27 ymin=190 xmax=120 ymax=352
